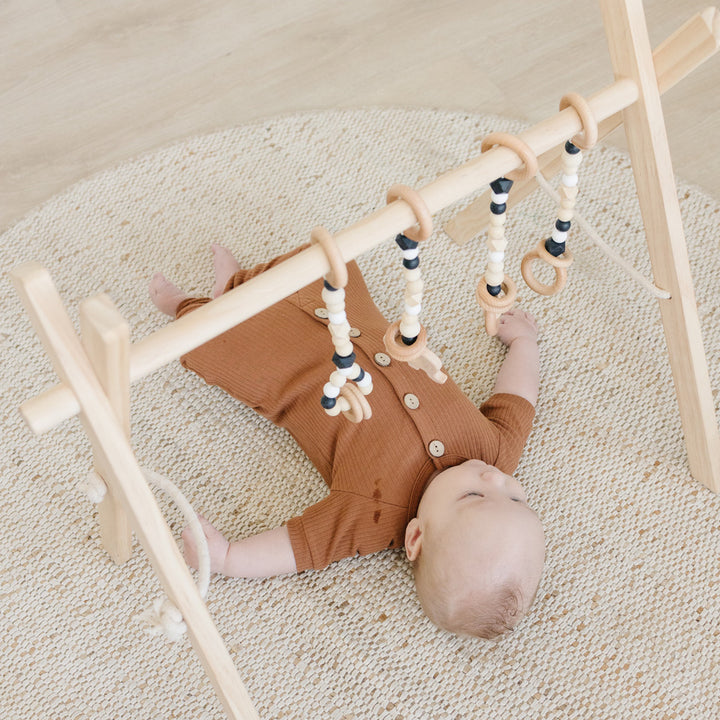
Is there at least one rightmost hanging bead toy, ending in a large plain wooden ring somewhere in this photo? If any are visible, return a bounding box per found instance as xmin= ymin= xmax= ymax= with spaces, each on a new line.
xmin=520 ymin=93 xmax=598 ymax=295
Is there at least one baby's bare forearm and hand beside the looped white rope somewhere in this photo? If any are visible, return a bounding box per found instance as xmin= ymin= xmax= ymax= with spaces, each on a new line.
xmin=183 ymin=515 xmax=297 ymax=578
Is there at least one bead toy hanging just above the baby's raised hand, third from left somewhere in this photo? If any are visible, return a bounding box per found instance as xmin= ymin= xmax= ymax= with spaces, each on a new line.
xmin=475 ymin=132 xmax=537 ymax=335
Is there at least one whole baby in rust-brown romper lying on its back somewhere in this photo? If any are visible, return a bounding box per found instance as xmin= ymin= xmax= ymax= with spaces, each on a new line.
xmin=149 ymin=246 xmax=545 ymax=638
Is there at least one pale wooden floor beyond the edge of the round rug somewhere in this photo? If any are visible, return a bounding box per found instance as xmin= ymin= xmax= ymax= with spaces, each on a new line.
xmin=0 ymin=0 xmax=720 ymax=229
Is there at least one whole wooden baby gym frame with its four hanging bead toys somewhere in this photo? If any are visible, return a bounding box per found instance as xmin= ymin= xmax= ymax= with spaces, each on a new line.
xmin=11 ymin=0 xmax=720 ymax=719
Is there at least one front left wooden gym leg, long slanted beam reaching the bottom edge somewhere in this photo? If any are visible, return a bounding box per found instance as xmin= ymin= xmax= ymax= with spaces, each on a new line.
xmin=10 ymin=263 xmax=257 ymax=720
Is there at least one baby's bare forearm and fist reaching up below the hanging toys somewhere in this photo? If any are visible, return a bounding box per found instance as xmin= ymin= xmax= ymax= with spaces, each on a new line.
xmin=493 ymin=308 xmax=540 ymax=407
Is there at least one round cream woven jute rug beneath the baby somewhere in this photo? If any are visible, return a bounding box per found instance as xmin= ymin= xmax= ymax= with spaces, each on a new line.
xmin=0 ymin=109 xmax=720 ymax=720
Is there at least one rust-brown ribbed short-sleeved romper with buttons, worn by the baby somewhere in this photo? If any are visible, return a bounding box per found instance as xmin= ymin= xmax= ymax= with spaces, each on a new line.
xmin=177 ymin=248 xmax=534 ymax=571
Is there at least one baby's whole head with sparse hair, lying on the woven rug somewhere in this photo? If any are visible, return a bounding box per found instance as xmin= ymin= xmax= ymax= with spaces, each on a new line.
xmin=405 ymin=460 xmax=545 ymax=638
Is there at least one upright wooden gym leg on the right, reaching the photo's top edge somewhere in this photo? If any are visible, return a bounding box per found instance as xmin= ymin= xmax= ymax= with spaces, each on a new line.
xmin=600 ymin=0 xmax=720 ymax=492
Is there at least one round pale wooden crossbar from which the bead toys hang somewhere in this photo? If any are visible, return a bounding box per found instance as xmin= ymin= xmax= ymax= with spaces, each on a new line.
xmin=21 ymin=74 xmax=637 ymax=433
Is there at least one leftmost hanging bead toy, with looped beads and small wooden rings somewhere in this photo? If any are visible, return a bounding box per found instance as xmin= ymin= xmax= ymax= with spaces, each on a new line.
xmin=310 ymin=227 xmax=372 ymax=423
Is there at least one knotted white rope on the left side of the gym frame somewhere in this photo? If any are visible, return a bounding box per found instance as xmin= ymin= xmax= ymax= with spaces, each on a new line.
xmin=84 ymin=468 xmax=210 ymax=641
